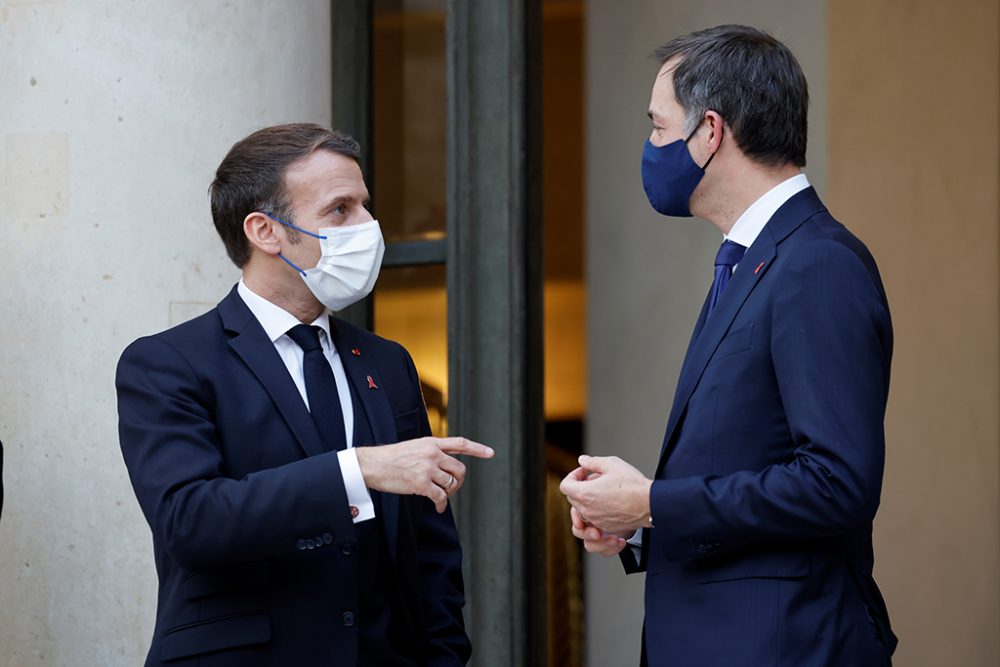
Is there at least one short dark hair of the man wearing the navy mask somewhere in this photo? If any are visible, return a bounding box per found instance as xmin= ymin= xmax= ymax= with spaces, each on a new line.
xmin=653 ymin=25 xmax=809 ymax=167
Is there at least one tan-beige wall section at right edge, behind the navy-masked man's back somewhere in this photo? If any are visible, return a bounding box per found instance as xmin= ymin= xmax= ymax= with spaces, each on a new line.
xmin=828 ymin=0 xmax=1000 ymax=667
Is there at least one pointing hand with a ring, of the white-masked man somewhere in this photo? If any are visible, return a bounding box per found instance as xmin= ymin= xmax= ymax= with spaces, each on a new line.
xmin=357 ymin=438 xmax=493 ymax=512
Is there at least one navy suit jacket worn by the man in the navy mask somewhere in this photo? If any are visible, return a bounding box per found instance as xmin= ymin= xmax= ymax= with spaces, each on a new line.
xmin=623 ymin=188 xmax=896 ymax=667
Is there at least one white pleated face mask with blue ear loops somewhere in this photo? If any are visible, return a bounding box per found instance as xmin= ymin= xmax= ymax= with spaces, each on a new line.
xmin=265 ymin=213 xmax=385 ymax=311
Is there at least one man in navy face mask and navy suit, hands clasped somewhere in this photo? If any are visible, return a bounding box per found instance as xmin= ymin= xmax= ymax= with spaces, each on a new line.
xmin=562 ymin=26 xmax=896 ymax=667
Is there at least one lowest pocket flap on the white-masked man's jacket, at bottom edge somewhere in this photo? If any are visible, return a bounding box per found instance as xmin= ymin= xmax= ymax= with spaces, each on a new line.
xmin=160 ymin=612 xmax=271 ymax=661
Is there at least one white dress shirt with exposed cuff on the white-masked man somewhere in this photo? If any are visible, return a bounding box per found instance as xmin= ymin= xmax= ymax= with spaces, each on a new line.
xmin=236 ymin=278 xmax=375 ymax=523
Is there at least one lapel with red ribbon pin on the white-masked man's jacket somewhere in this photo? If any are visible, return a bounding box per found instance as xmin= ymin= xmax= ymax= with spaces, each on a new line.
xmin=330 ymin=317 xmax=399 ymax=560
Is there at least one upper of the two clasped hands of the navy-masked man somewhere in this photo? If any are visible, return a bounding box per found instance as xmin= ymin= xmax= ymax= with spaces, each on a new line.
xmin=559 ymin=455 xmax=653 ymax=536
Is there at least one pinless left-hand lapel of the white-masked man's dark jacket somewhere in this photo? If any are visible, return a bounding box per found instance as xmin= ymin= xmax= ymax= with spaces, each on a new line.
xmin=218 ymin=287 xmax=327 ymax=456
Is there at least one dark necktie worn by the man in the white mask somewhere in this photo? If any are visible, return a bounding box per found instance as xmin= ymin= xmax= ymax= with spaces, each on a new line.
xmin=288 ymin=324 xmax=347 ymax=451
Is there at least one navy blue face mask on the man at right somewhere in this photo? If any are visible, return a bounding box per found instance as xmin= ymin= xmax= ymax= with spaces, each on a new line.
xmin=642 ymin=123 xmax=715 ymax=218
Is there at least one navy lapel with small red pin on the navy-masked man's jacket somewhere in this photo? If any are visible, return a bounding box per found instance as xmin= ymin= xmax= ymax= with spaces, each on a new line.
xmin=657 ymin=188 xmax=825 ymax=474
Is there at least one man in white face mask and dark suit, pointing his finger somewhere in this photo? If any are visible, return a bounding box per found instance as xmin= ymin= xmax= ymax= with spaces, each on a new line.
xmin=117 ymin=124 xmax=492 ymax=667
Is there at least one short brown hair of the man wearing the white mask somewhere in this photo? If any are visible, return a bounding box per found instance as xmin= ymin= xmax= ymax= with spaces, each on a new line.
xmin=208 ymin=123 xmax=361 ymax=268
